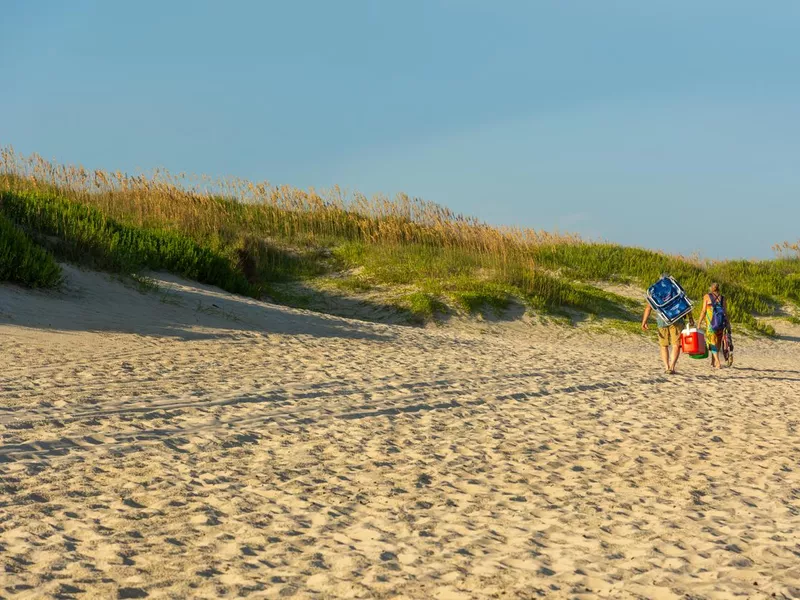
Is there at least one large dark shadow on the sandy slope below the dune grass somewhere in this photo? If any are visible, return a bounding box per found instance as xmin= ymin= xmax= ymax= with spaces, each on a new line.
xmin=0 ymin=265 xmax=395 ymax=341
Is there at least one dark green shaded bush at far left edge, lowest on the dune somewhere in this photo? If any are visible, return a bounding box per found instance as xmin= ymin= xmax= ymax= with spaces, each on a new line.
xmin=0 ymin=214 xmax=61 ymax=288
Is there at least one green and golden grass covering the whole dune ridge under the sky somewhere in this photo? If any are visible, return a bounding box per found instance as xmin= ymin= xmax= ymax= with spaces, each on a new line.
xmin=0 ymin=148 xmax=800 ymax=335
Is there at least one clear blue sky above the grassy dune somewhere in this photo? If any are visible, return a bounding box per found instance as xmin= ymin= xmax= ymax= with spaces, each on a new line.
xmin=0 ymin=0 xmax=800 ymax=258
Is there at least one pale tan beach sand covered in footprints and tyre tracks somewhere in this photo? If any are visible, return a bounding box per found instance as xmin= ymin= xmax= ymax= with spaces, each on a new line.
xmin=0 ymin=267 xmax=800 ymax=600
